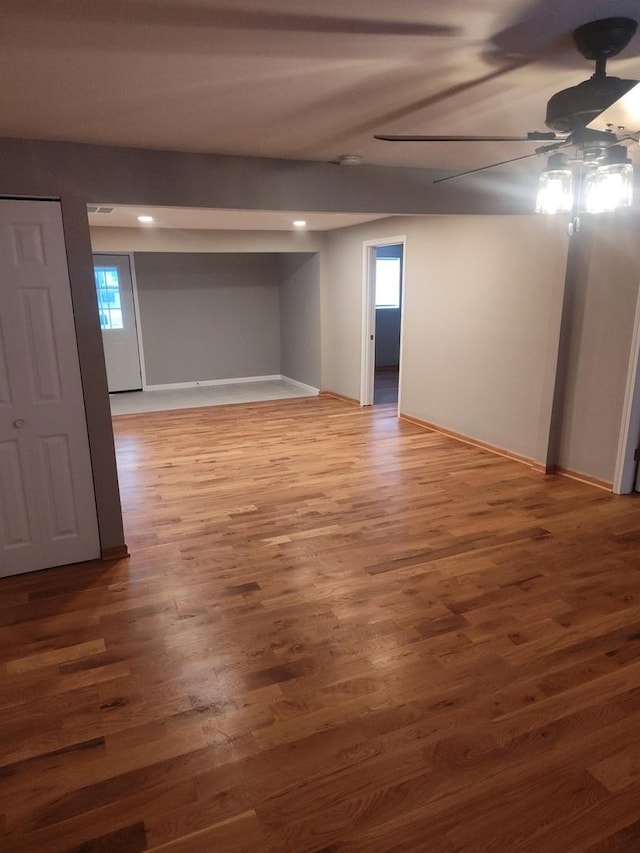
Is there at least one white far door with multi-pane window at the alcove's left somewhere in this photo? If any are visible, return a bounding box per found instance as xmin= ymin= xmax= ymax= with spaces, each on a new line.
xmin=93 ymin=255 xmax=142 ymax=392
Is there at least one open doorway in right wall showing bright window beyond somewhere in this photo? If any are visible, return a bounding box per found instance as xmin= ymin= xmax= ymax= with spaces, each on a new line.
xmin=360 ymin=237 xmax=405 ymax=407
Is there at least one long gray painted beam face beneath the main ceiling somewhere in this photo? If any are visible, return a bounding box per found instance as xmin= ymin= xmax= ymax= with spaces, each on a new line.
xmin=0 ymin=139 xmax=537 ymax=213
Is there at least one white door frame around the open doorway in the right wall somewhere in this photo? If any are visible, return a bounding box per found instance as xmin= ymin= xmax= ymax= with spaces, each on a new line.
xmin=360 ymin=234 xmax=407 ymax=414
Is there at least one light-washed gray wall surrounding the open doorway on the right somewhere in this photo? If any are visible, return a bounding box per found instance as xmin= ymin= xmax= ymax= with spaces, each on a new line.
xmin=323 ymin=216 xmax=567 ymax=464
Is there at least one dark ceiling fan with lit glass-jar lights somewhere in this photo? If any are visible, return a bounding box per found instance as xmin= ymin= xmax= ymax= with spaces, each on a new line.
xmin=374 ymin=17 xmax=640 ymax=188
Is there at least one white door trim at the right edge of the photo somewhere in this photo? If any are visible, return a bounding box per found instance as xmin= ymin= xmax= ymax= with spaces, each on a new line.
xmin=613 ymin=282 xmax=640 ymax=495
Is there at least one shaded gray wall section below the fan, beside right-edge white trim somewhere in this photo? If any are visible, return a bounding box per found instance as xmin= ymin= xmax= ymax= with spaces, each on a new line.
xmin=557 ymin=213 xmax=640 ymax=482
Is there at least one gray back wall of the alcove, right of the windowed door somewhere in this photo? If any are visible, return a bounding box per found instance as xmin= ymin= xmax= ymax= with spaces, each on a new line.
xmin=134 ymin=252 xmax=280 ymax=385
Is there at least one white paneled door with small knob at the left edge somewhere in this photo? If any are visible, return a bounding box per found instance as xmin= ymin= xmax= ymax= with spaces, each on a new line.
xmin=0 ymin=199 xmax=100 ymax=576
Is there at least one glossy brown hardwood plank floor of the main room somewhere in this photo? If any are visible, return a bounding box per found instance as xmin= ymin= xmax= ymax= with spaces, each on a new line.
xmin=0 ymin=398 xmax=640 ymax=853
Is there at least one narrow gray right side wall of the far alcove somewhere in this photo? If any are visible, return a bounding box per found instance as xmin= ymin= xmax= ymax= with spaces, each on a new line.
xmin=279 ymin=253 xmax=320 ymax=388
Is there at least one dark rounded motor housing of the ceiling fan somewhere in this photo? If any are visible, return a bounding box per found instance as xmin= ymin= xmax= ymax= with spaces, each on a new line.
xmin=545 ymin=75 xmax=638 ymax=133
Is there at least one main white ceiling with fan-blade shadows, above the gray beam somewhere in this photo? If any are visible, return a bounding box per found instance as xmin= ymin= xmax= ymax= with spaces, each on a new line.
xmin=0 ymin=0 xmax=640 ymax=176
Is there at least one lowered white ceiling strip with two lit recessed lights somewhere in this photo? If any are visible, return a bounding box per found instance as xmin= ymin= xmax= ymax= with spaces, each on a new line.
xmin=89 ymin=204 xmax=388 ymax=231
